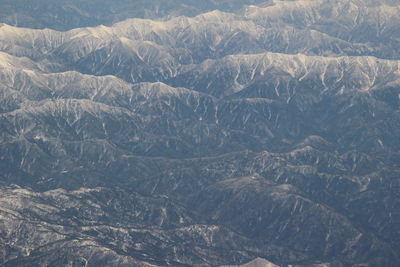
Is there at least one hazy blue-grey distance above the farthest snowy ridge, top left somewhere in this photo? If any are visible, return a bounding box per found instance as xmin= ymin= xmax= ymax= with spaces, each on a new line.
xmin=0 ymin=0 xmax=263 ymax=30
